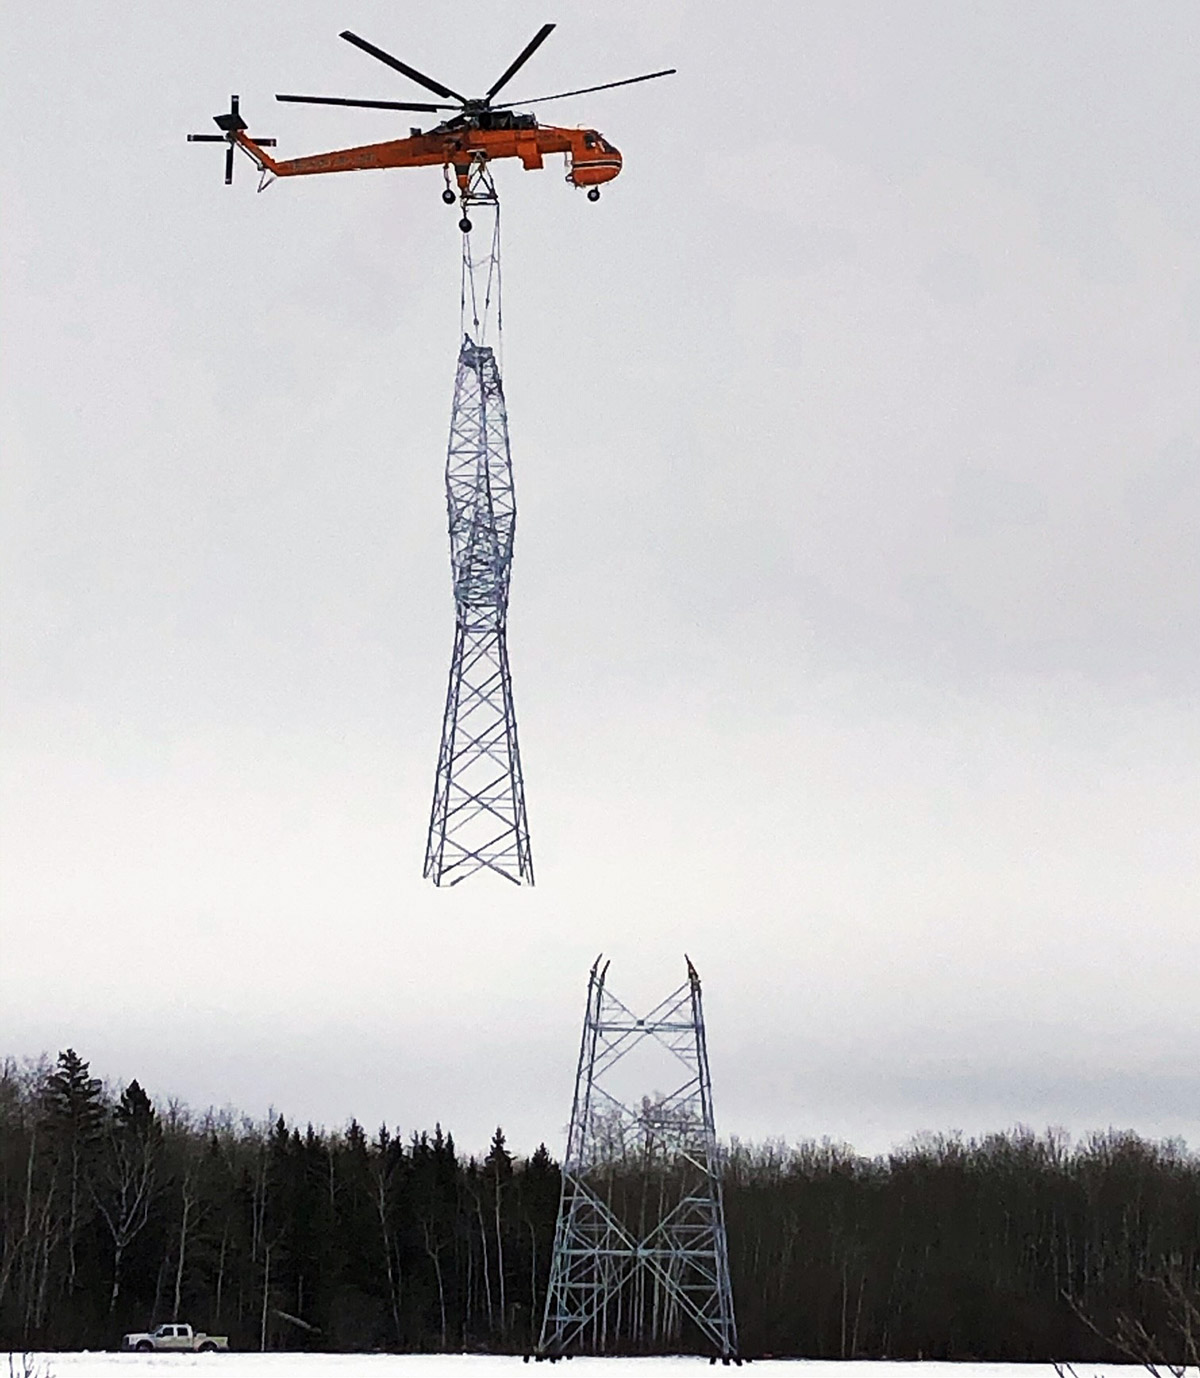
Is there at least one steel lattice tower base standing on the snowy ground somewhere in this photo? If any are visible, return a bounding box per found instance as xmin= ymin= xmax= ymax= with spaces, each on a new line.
xmin=537 ymin=959 xmax=740 ymax=1363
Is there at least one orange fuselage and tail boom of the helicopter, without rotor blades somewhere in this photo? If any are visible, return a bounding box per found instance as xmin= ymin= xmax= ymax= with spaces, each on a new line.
xmin=233 ymin=120 xmax=621 ymax=189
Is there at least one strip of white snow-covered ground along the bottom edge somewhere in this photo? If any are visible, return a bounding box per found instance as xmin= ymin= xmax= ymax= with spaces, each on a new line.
xmin=0 ymin=1353 xmax=1142 ymax=1378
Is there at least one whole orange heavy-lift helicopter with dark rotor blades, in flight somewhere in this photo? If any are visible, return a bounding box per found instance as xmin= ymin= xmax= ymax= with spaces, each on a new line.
xmin=187 ymin=23 xmax=675 ymax=230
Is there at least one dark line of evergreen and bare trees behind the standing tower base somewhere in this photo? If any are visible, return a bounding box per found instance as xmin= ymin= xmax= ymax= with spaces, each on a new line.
xmin=0 ymin=1049 xmax=1200 ymax=1361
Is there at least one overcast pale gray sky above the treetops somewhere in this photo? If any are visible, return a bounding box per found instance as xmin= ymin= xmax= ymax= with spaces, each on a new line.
xmin=0 ymin=0 xmax=1200 ymax=1151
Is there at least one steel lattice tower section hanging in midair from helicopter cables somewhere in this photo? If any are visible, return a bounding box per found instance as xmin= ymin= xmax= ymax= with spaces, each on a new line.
xmin=424 ymin=336 xmax=533 ymax=885
